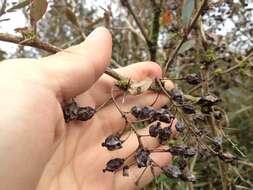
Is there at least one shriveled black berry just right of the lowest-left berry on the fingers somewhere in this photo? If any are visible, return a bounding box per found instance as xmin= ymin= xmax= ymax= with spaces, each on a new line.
xmin=135 ymin=148 xmax=150 ymax=168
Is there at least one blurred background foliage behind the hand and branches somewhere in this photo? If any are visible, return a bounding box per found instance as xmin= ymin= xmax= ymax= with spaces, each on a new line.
xmin=0 ymin=0 xmax=253 ymax=190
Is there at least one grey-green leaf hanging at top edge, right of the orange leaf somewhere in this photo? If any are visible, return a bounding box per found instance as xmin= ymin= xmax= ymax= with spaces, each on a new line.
xmin=181 ymin=0 xmax=195 ymax=27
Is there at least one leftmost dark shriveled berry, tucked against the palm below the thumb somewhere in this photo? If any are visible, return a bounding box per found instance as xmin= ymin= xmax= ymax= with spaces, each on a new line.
xmin=62 ymin=99 xmax=79 ymax=123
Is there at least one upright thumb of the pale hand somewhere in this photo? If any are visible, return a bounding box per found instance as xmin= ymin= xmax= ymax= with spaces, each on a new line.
xmin=42 ymin=27 xmax=112 ymax=100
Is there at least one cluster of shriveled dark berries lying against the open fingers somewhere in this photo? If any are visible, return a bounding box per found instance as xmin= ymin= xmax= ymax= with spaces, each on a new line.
xmin=102 ymin=106 xmax=197 ymax=182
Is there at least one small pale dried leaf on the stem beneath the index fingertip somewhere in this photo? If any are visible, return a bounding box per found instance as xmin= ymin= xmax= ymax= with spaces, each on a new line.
xmin=128 ymin=78 xmax=153 ymax=95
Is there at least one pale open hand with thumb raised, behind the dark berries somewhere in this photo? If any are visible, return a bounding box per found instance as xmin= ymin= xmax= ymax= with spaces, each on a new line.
xmin=0 ymin=28 xmax=173 ymax=190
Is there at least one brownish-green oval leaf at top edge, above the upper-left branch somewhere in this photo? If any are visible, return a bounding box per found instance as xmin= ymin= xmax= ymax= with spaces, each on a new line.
xmin=30 ymin=0 xmax=48 ymax=22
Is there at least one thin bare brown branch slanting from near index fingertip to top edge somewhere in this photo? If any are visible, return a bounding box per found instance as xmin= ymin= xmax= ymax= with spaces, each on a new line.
xmin=163 ymin=0 xmax=207 ymax=76
